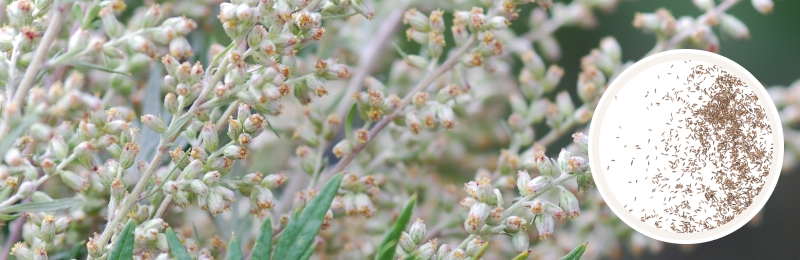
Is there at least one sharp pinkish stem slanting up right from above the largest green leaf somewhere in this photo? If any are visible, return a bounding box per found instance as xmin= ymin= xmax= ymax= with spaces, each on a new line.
xmin=321 ymin=34 xmax=476 ymax=187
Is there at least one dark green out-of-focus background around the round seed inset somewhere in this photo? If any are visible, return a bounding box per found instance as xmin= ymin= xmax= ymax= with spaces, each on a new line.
xmin=544 ymin=0 xmax=800 ymax=259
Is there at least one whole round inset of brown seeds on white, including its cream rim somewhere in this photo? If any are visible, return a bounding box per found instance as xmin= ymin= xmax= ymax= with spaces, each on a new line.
xmin=589 ymin=50 xmax=783 ymax=244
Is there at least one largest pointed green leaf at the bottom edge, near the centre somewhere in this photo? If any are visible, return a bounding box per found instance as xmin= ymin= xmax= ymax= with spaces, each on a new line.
xmin=273 ymin=173 xmax=343 ymax=260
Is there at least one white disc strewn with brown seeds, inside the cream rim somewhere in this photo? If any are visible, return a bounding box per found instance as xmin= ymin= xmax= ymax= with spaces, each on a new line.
xmin=601 ymin=60 xmax=773 ymax=233
